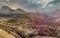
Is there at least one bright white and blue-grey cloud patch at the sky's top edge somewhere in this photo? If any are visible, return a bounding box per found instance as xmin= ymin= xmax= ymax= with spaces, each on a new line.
xmin=27 ymin=0 xmax=54 ymax=8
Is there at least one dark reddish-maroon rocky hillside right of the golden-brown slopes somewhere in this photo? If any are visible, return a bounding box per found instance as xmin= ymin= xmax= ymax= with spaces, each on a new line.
xmin=27 ymin=14 xmax=57 ymax=36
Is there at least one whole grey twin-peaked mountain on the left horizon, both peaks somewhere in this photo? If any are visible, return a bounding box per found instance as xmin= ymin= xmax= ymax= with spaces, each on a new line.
xmin=0 ymin=6 xmax=25 ymax=14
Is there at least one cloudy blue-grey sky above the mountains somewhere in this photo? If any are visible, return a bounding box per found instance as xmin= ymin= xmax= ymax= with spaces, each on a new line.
xmin=0 ymin=0 xmax=60 ymax=13
